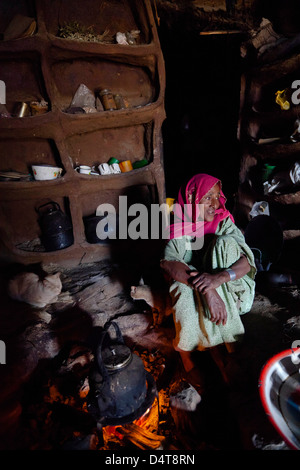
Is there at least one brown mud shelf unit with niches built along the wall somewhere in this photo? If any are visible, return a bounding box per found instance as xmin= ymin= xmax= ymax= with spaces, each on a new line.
xmin=0 ymin=0 xmax=165 ymax=264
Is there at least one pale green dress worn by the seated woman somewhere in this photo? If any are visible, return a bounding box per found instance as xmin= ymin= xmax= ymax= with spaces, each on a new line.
xmin=164 ymin=217 xmax=256 ymax=351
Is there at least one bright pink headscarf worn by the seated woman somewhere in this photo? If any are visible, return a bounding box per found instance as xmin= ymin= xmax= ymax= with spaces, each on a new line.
xmin=169 ymin=173 xmax=234 ymax=239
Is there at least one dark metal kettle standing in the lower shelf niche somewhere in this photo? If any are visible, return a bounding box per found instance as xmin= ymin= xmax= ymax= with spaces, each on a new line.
xmin=37 ymin=201 xmax=74 ymax=251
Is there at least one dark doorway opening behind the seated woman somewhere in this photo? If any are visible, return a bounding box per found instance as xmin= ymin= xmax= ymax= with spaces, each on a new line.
xmin=159 ymin=20 xmax=242 ymax=204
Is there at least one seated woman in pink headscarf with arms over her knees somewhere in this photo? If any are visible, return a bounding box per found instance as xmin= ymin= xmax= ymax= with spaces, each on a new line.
xmin=161 ymin=174 xmax=256 ymax=392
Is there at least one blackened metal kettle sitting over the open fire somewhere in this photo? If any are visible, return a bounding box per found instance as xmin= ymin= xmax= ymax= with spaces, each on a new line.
xmin=89 ymin=321 xmax=156 ymax=425
